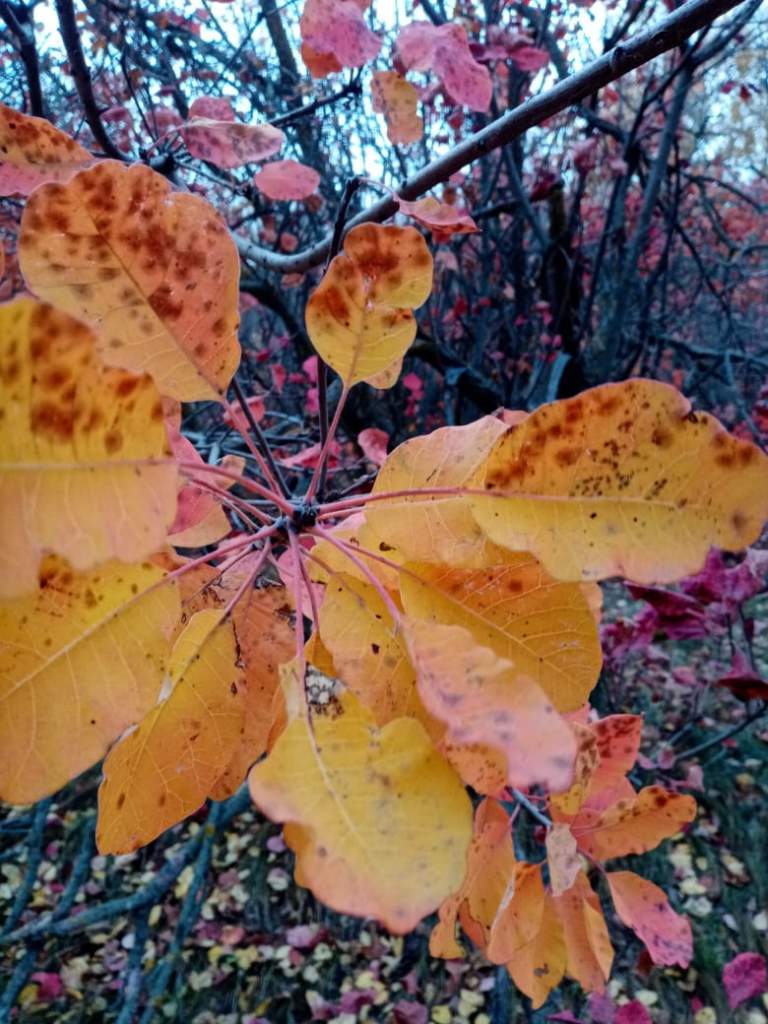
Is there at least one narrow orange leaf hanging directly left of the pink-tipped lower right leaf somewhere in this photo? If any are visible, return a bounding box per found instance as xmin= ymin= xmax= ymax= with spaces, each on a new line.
xmin=553 ymin=872 xmax=613 ymax=992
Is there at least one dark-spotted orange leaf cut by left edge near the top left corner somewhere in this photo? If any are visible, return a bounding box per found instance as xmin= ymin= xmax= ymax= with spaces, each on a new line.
xmin=0 ymin=103 xmax=93 ymax=196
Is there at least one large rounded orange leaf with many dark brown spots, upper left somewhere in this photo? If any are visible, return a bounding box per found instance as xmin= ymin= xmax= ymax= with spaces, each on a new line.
xmin=18 ymin=160 xmax=240 ymax=401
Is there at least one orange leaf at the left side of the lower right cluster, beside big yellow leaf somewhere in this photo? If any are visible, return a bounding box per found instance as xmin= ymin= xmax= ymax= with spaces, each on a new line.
xmin=429 ymin=799 xmax=516 ymax=959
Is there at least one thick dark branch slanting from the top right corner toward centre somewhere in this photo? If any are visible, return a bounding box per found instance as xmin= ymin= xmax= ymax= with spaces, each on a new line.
xmin=238 ymin=0 xmax=743 ymax=273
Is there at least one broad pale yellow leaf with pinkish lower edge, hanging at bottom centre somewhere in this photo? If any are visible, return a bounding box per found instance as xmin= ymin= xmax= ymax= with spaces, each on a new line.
xmin=250 ymin=692 xmax=472 ymax=933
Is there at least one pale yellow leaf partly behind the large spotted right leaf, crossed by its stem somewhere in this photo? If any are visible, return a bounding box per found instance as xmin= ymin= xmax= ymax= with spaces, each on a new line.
xmin=366 ymin=416 xmax=507 ymax=568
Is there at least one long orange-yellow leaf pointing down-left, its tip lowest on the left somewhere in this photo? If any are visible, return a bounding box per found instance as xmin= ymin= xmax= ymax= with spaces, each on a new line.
xmin=96 ymin=608 xmax=245 ymax=853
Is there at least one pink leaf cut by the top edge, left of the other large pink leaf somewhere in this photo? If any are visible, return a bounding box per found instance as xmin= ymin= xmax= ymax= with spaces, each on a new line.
xmin=300 ymin=0 xmax=381 ymax=68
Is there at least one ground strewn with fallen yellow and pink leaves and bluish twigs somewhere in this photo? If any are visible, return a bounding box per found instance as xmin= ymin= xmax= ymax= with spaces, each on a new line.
xmin=0 ymin=566 xmax=768 ymax=1024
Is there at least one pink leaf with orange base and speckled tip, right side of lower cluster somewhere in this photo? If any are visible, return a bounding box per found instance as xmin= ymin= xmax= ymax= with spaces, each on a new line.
xmin=605 ymin=871 xmax=693 ymax=968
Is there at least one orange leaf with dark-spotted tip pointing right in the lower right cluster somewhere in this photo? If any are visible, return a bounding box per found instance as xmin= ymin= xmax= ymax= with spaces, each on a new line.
xmin=571 ymin=785 xmax=696 ymax=860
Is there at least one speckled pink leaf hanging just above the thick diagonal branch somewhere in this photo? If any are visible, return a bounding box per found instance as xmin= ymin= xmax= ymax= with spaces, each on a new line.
xmin=395 ymin=22 xmax=494 ymax=112
